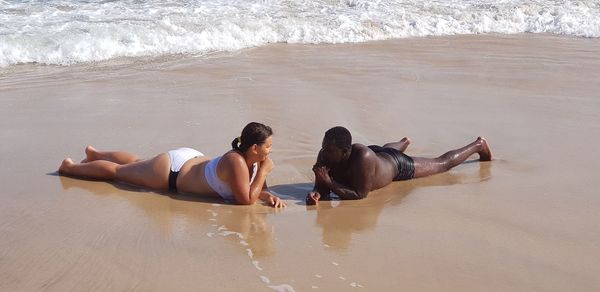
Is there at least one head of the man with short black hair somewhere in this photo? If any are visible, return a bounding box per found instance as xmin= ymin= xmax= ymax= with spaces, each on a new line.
xmin=321 ymin=126 xmax=352 ymax=165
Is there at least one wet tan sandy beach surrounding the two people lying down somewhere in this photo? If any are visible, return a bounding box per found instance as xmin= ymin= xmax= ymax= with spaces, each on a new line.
xmin=0 ymin=34 xmax=600 ymax=291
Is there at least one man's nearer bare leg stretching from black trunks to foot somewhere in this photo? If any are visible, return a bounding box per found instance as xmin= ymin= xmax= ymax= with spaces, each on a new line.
xmin=413 ymin=137 xmax=492 ymax=178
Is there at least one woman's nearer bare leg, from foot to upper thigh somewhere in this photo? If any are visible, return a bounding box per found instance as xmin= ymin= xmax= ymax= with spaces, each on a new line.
xmin=58 ymin=153 xmax=171 ymax=189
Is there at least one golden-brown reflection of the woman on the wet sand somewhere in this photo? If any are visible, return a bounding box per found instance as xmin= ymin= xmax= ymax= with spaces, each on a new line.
xmin=59 ymin=176 xmax=278 ymax=258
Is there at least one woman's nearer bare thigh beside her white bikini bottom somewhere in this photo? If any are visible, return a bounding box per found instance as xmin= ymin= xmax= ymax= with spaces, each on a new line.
xmin=117 ymin=153 xmax=171 ymax=190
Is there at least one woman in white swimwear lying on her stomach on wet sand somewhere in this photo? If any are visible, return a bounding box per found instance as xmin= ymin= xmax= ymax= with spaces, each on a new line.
xmin=58 ymin=123 xmax=286 ymax=208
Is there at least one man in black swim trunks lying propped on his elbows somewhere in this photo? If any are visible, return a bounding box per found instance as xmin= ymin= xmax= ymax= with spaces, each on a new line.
xmin=306 ymin=126 xmax=492 ymax=205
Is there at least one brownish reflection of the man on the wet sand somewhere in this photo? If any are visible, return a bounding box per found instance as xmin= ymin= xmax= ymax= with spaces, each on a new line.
xmin=308 ymin=162 xmax=491 ymax=249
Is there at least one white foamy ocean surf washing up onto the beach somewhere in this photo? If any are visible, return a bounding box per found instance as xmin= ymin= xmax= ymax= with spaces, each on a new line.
xmin=0 ymin=0 xmax=600 ymax=67
